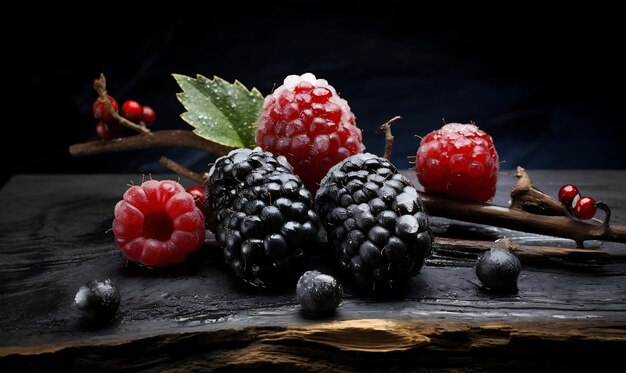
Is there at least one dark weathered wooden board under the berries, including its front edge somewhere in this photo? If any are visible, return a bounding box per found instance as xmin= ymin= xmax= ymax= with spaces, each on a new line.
xmin=0 ymin=171 xmax=626 ymax=370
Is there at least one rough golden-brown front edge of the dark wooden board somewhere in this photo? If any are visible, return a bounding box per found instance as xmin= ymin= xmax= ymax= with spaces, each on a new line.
xmin=0 ymin=319 xmax=626 ymax=372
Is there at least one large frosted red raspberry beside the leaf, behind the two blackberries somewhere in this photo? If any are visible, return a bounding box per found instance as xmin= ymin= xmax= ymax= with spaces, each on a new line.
xmin=256 ymin=73 xmax=365 ymax=192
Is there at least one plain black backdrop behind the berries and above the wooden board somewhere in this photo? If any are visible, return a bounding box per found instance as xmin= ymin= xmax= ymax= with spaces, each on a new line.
xmin=6 ymin=2 xmax=626 ymax=186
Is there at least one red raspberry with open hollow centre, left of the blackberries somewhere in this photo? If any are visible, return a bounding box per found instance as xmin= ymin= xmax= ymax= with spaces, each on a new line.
xmin=113 ymin=180 xmax=205 ymax=266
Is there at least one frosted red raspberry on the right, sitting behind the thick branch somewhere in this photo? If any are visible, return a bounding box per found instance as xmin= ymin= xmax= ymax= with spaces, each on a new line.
xmin=415 ymin=123 xmax=499 ymax=202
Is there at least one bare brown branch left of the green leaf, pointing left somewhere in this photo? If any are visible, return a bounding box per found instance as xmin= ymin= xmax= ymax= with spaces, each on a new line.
xmin=69 ymin=130 xmax=232 ymax=157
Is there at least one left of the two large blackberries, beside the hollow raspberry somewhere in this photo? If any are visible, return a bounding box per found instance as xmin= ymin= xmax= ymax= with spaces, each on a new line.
xmin=207 ymin=148 xmax=320 ymax=287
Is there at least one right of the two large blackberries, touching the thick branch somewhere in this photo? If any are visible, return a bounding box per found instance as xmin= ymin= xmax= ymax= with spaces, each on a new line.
xmin=315 ymin=153 xmax=433 ymax=290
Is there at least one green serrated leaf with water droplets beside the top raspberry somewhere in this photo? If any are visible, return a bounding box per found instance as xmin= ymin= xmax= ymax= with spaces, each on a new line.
xmin=173 ymin=74 xmax=263 ymax=148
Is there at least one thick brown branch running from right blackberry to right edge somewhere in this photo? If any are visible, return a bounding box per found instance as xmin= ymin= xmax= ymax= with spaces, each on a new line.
xmin=418 ymin=192 xmax=626 ymax=246
